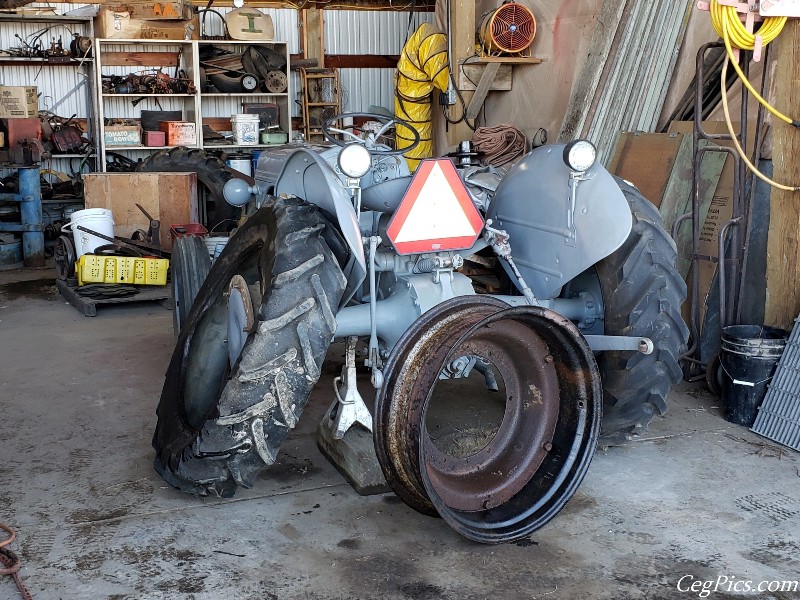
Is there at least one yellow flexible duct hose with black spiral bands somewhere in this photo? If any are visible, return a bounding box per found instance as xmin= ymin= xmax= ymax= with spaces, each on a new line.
xmin=394 ymin=23 xmax=449 ymax=171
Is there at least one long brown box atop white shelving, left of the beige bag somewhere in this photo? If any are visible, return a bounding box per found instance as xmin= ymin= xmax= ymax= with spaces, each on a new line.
xmin=94 ymin=8 xmax=200 ymax=40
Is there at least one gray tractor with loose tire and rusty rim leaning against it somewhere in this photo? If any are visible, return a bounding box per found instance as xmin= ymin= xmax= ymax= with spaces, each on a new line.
xmin=153 ymin=114 xmax=688 ymax=542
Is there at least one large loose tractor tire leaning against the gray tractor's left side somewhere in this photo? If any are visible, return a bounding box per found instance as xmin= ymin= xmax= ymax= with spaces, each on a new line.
xmin=153 ymin=199 xmax=345 ymax=497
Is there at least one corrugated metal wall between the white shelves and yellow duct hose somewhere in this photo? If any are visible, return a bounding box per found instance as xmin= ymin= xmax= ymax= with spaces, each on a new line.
xmin=325 ymin=10 xmax=434 ymax=112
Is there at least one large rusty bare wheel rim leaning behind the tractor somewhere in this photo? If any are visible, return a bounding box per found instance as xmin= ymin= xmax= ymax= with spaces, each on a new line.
xmin=375 ymin=298 xmax=602 ymax=543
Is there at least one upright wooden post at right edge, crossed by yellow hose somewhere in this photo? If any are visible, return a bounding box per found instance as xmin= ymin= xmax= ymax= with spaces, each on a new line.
xmin=764 ymin=19 xmax=800 ymax=329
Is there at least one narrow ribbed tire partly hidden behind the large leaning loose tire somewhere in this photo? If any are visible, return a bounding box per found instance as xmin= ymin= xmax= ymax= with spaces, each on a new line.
xmin=169 ymin=235 xmax=211 ymax=337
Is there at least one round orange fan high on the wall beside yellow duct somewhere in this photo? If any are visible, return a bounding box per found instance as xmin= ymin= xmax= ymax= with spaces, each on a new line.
xmin=478 ymin=2 xmax=536 ymax=54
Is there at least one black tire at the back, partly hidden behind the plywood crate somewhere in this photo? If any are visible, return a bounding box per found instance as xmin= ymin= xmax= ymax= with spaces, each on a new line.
xmin=136 ymin=147 xmax=239 ymax=231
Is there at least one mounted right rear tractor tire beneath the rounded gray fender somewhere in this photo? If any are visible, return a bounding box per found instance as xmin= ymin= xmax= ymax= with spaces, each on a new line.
xmin=595 ymin=180 xmax=689 ymax=440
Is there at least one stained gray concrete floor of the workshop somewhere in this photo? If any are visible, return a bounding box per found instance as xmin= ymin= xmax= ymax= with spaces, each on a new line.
xmin=0 ymin=270 xmax=800 ymax=600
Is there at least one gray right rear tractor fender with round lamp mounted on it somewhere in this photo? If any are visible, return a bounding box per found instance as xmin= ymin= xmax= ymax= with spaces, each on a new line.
xmin=487 ymin=144 xmax=633 ymax=299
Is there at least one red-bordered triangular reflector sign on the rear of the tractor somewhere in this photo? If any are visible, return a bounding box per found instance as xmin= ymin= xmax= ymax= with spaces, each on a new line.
xmin=387 ymin=158 xmax=483 ymax=254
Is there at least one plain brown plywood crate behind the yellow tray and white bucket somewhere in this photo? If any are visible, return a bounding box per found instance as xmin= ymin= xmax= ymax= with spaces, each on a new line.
xmin=83 ymin=173 xmax=199 ymax=250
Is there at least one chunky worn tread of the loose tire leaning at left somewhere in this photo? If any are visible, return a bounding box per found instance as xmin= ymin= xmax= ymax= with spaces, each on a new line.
xmin=153 ymin=198 xmax=345 ymax=497
